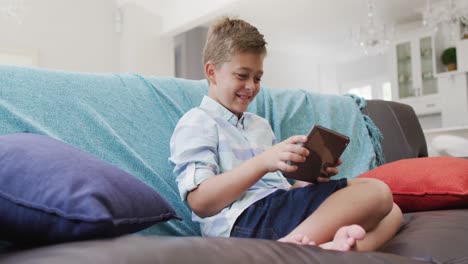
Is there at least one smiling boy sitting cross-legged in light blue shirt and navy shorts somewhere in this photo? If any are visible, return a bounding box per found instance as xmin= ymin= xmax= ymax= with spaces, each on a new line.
xmin=170 ymin=18 xmax=402 ymax=251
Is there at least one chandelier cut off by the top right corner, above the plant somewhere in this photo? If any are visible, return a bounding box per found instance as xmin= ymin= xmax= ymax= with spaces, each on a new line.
xmin=423 ymin=0 xmax=468 ymax=39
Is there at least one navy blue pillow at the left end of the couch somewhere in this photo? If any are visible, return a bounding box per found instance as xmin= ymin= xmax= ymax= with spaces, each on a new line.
xmin=0 ymin=133 xmax=180 ymax=244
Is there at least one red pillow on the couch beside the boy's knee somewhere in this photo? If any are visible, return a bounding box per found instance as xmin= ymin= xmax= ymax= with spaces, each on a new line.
xmin=358 ymin=157 xmax=468 ymax=212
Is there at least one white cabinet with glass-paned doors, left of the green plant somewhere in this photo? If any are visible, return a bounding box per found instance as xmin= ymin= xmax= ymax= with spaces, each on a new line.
xmin=391 ymin=34 xmax=441 ymax=115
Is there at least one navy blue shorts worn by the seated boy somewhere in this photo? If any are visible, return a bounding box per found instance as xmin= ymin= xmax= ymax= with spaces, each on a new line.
xmin=231 ymin=179 xmax=348 ymax=240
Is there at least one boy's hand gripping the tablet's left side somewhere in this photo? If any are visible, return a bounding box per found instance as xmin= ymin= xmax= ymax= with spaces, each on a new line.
xmin=260 ymin=135 xmax=309 ymax=172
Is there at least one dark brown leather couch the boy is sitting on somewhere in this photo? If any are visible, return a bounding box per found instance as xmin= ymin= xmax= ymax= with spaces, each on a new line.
xmin=0 ymin=100 xmax=468 ymax=264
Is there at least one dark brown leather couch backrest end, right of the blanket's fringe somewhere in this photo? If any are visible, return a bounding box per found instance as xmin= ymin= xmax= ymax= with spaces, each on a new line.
xmin=363 ymin=100 xmax=428 ymax=163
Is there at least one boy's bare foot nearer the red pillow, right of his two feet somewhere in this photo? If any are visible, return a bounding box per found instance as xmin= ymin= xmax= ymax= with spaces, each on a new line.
xmin=319 ymin=225 xmax=366 ymax=251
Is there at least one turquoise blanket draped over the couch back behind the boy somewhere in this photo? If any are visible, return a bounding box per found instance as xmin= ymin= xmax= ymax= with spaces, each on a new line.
xmin=0 ymin=66 xmax=376 ymax=236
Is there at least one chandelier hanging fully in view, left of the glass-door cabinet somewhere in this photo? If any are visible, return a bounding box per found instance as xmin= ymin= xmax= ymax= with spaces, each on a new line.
xmin=351 ymin=0 xmax=394 ymax=55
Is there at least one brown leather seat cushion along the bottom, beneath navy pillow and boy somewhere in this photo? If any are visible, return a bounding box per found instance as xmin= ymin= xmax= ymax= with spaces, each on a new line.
xmin=0 ymin=235 xmax=435 ymax=264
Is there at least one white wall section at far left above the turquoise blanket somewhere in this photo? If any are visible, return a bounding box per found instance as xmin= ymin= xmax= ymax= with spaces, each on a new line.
xmin=0 ymin=0 xmax=119 ymax=72
